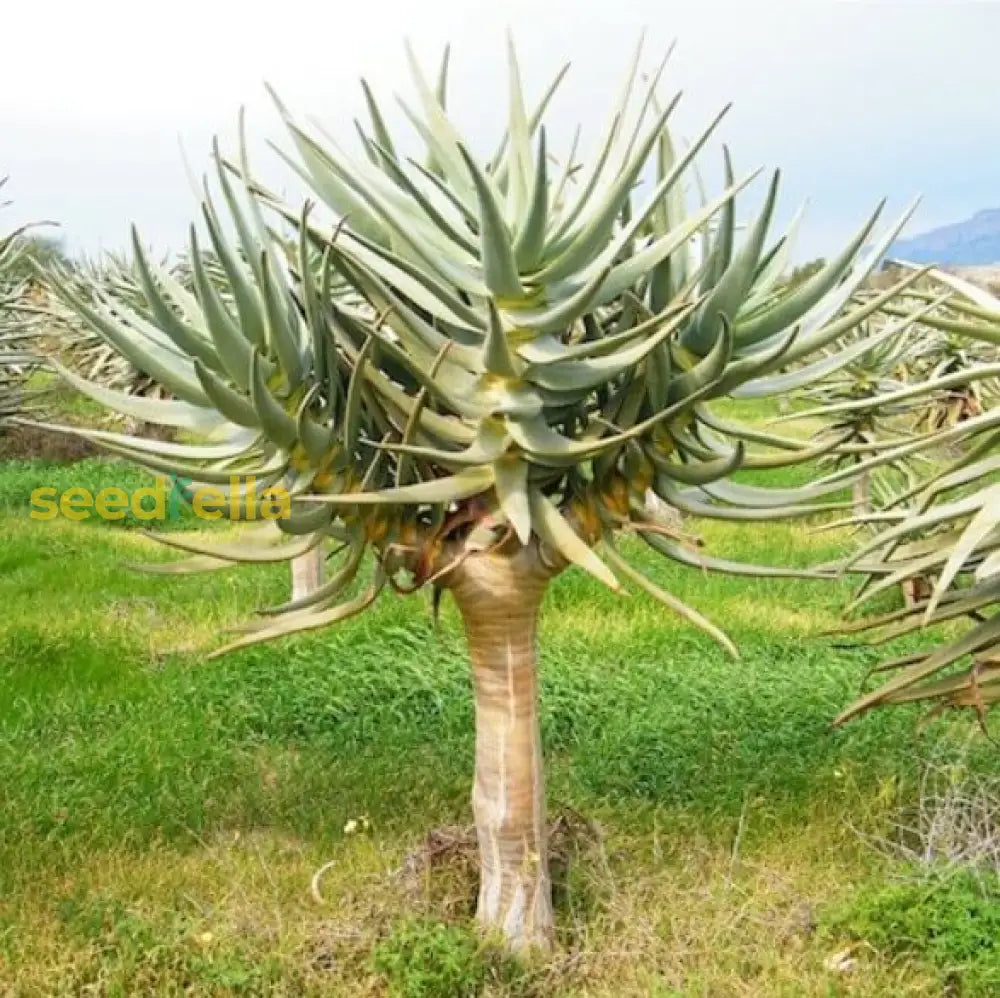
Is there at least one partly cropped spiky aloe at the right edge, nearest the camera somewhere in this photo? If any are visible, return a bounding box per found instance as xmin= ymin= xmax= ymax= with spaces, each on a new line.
xmin=839 ymin=270 xmax=1000 ymax=721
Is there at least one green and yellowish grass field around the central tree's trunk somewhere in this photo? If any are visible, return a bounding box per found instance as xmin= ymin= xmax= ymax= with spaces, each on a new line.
xmin=0 ymin=434 xmax=1000 ymax=996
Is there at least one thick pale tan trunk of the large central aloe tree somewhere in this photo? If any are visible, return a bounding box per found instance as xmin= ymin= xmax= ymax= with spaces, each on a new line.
xmin=447 ymin=547 xmax=553 ymax=950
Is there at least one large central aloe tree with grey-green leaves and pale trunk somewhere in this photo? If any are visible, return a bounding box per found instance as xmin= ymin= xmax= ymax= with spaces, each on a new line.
xmin=45 ymin=43 xmax=911 ymax=948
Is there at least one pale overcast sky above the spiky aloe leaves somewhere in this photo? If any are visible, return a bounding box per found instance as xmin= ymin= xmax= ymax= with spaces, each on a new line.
xmin=0 ymin=0 xmax=1000 ymax=258
